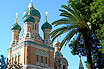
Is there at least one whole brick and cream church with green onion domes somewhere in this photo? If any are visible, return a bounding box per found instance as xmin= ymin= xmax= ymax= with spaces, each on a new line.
xmin=8 ymin=0 xmax=68 ymax=69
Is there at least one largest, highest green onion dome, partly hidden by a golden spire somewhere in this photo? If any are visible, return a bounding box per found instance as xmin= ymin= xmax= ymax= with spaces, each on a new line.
xmin=23 ymin=7 xmax=41 ymax=19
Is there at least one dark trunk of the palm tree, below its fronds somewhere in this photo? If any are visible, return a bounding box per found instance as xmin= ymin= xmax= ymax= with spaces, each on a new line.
xmin=82 ymin=32 xmax=93 ymax=69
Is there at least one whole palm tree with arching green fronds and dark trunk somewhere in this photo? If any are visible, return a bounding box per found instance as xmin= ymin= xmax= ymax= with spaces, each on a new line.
xmin=50 ymin=2 xmax=92 ymax=69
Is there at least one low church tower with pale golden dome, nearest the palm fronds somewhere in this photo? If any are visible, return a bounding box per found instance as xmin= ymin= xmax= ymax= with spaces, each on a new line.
xmin=54 ymin=38 xmax=68 ymax=69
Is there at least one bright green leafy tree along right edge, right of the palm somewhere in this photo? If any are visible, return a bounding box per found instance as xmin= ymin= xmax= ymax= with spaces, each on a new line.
xmin=90 ymin=0 xmax=104 ymax=69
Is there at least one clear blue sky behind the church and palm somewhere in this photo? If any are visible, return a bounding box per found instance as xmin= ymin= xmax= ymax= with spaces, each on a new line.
xmin=0 ymin=0 xmax=87 ymax=69
